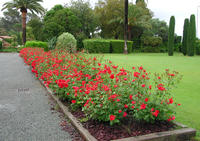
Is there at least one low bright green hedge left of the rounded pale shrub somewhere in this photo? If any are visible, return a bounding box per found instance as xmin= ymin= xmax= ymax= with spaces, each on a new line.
xmin=25 ymin=41 xmax=48 ymax=51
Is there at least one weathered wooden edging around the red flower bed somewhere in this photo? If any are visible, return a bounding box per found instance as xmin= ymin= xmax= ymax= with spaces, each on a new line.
xmin=25 ymin=63 xmax=196 ymax=141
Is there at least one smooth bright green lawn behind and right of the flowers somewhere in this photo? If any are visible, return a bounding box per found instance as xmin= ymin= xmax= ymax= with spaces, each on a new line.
xmin=99 ymin=53 xmax=200 ymax=137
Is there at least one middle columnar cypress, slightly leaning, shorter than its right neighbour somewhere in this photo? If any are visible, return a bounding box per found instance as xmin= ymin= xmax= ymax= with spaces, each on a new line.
xmin=181 ymin=19 xmax=189 ymax=55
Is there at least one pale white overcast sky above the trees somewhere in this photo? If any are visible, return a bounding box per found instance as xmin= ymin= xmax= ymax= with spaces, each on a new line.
xmin=0 ymin=0 xmax=200 ymax=37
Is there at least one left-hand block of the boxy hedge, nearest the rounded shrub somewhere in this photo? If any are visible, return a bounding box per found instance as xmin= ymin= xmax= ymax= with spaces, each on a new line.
xmin=83 ymin=39 xmax=110 ymax=53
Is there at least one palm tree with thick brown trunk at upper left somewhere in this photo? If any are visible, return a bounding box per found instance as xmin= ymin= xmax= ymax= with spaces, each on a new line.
xmin=2 ymin=0 xmax=44 ymax=44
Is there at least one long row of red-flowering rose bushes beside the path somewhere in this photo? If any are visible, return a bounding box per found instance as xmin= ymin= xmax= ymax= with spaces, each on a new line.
xmin=20 ymin=48 xmax=181 ymax=125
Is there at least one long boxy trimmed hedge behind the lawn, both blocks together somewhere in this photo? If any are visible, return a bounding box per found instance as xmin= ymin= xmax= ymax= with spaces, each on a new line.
xmin=83 ymin=39 xmax=133 ymax=53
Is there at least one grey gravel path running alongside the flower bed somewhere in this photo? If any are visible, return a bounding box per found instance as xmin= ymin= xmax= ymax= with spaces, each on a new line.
xmin=0 ymin=53 xmax=72 ymax=141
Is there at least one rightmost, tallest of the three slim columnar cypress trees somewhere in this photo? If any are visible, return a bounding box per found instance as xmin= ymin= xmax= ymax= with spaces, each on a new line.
xmin=188 ymin=15 xmax=196 ymax=56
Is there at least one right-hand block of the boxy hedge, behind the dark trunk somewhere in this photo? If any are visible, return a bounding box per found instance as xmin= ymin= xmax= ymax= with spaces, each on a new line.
xmin=110 ymin=40 xmax=133 ymax=53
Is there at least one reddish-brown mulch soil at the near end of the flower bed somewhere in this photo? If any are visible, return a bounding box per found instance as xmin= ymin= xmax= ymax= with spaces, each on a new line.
xmin=72 ymin=107 xmax=176 ymax=141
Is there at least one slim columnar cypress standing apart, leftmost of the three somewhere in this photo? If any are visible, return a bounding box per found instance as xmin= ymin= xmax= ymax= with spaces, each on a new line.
xmin=168 ymin=16 xmax=175 ymax=56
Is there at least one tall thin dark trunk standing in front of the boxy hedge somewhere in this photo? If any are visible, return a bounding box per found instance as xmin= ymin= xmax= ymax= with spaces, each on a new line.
xmin=124 ymin=0 xmax=128 ymax=54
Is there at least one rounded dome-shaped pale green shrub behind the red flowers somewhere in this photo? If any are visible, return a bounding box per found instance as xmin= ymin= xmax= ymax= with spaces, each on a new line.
xmin=56 ymin=32 xmax=77 ymax=52
